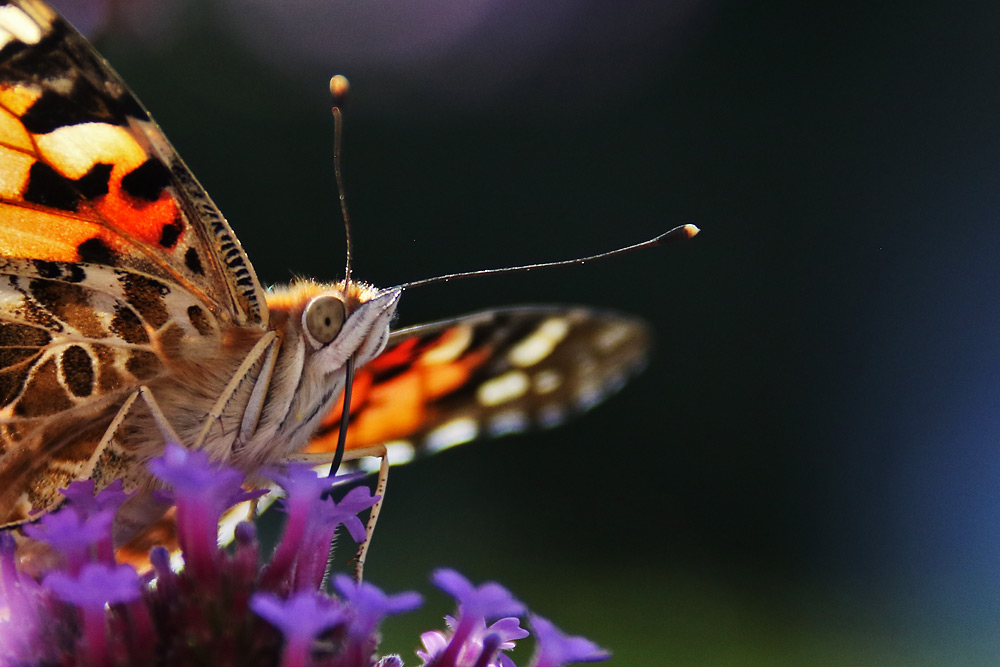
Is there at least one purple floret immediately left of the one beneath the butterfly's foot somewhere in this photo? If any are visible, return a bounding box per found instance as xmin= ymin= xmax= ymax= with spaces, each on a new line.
xmin=250 ymin=592 xmax=346 ymax=667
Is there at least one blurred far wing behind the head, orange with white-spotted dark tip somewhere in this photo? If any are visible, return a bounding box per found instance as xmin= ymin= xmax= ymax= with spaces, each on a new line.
xmin=306 ymin=306 xmax=650 ymax=463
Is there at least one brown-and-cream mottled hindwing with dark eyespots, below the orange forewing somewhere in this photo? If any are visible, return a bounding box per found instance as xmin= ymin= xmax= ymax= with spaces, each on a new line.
xmin=0 ymin=259 xmax=227 ymax=524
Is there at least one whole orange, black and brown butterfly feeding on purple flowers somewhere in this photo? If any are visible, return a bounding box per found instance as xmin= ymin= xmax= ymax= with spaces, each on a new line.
xmin=0 ymin=0 xmax=696 ymax=564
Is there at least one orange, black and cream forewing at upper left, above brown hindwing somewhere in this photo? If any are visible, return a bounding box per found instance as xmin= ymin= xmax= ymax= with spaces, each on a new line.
xmin=0 ymin=0 xmax=267 ymax=324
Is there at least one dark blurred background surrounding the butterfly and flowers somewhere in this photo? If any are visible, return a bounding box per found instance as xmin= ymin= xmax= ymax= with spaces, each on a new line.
xmin=52 ymin=0 xmax=1000 ymax=665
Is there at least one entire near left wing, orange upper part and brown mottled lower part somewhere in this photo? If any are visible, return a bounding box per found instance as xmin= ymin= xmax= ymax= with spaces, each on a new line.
xmin=0 ymin=0 xmax=267 ymax=525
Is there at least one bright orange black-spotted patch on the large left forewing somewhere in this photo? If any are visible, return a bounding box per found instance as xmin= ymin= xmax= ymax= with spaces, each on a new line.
xmin=0 ymin=107 xmax=190 ymax=276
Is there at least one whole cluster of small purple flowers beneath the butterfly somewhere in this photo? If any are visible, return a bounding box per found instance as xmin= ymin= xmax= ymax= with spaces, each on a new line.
xmin=0 ymin=446 xmax=608 ymax=667
